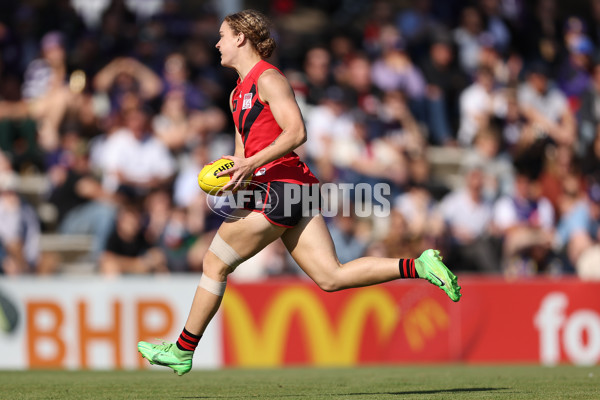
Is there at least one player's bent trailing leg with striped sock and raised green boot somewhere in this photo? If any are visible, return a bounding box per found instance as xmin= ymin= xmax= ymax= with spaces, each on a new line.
xmin=281 ymin=215 xmax=460 ymax=301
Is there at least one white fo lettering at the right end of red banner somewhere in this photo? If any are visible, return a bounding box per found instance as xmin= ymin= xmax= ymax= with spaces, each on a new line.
xmin=534 ymin=292 xmax=600 ymax=365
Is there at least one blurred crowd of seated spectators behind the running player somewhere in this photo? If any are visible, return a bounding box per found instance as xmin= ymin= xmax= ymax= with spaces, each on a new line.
xmin=0 ymin=0 xmax=600 ymax=279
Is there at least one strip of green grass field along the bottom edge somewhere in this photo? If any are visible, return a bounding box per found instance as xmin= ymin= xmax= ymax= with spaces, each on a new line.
xmin=0 ymin=365 xmax=600 ymax=400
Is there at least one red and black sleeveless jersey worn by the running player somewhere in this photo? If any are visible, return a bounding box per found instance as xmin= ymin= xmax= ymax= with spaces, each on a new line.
xmin=231 ymin=60 xmax=319 ymax=184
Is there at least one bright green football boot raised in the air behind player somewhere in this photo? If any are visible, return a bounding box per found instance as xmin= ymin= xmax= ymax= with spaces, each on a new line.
xmin=415 ymin=249 xmax=462 ymax=301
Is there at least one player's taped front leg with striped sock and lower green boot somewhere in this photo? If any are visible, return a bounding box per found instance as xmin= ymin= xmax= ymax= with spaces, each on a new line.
xmin=138 ymin=210 xmax=285 ymax=375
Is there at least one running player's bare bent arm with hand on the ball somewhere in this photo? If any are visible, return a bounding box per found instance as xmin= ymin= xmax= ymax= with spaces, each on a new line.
xmin=220 ymin=69 xmax=306 ymax=189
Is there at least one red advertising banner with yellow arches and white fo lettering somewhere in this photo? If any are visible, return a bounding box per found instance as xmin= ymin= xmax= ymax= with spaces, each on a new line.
xmin=222 ymin=278 xmax=600 ymax=367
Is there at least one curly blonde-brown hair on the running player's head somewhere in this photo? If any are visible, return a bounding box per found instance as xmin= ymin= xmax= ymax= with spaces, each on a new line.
xmin=225 ymin=10 xmax=275 ymax=59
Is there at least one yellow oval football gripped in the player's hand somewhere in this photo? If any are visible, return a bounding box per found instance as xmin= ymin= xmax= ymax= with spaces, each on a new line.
xmin=198 ymin=156 xmax=253 ymax=196
